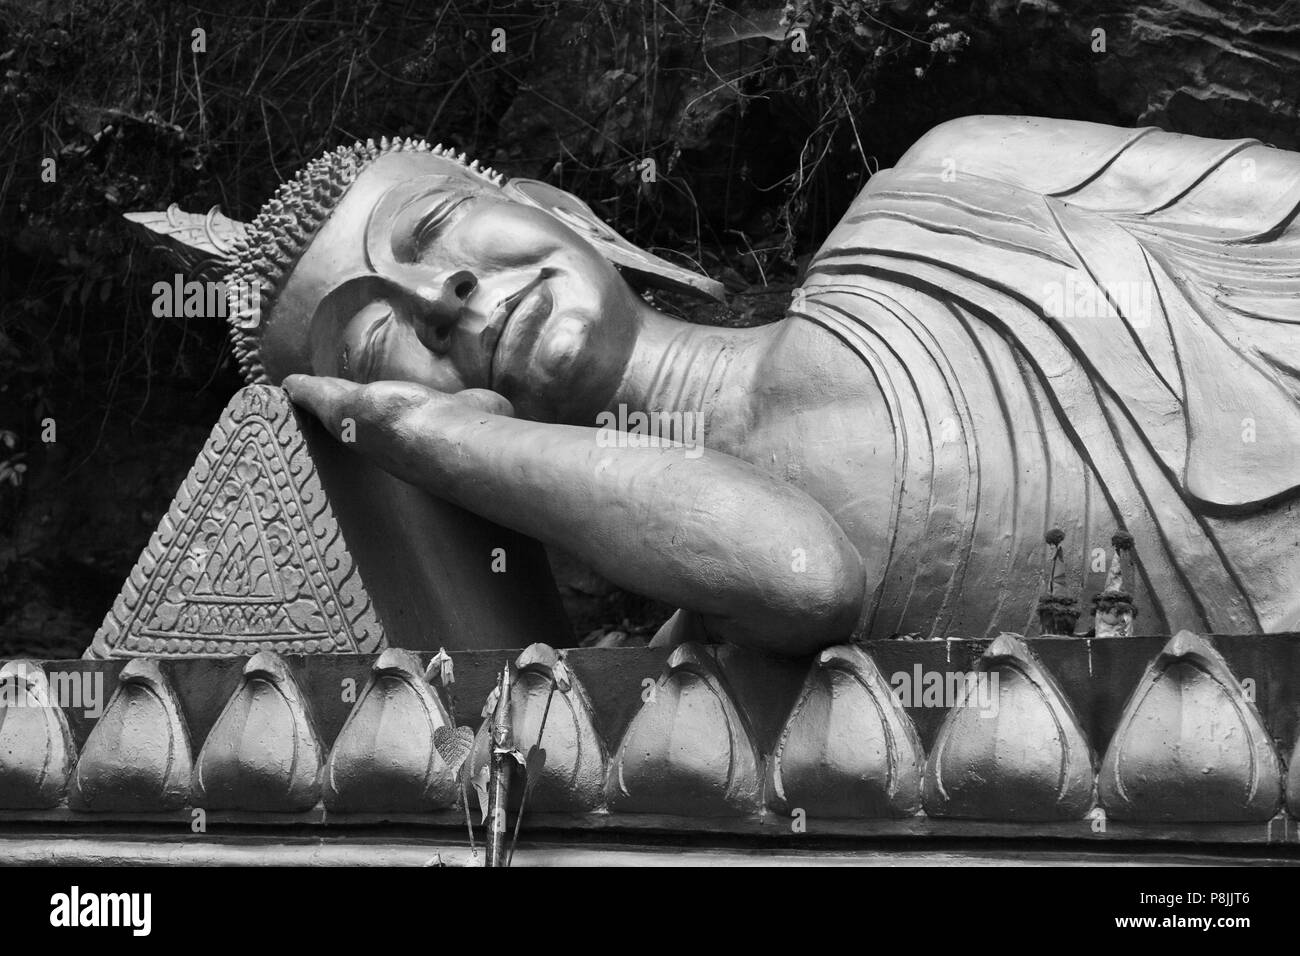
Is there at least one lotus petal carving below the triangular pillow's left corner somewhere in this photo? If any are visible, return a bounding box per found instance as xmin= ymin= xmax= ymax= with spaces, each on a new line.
xmin=72 ymin=657 xmax=194 ymax=812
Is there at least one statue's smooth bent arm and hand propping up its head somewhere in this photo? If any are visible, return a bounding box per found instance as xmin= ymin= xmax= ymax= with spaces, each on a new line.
xmin=285 ymin=376 xmax=865 ymax=654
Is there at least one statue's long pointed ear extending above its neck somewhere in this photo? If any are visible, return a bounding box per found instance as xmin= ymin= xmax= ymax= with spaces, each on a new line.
xmin=504 ymin=179 xmax=727 ymax=302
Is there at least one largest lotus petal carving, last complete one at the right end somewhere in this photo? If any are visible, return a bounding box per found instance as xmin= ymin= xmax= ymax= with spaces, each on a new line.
xmin=1101 ymin=631 xmax=1282 ymax=822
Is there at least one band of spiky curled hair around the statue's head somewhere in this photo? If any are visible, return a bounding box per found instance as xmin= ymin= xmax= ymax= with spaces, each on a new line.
xmin=225 ymin=137 xmax=506 ymax=384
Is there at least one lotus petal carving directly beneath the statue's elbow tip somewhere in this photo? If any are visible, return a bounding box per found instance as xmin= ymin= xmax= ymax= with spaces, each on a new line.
xmin=767 ymin=645 xmax=926 ymax=817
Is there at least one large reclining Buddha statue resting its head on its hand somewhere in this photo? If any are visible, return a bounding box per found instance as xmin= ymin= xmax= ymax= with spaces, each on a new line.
xmin=126 ymin=116 xmax=1300 ymax=654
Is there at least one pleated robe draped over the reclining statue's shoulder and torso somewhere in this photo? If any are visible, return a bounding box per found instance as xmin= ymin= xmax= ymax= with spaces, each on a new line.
xmin=794 ymin=116 xmax=1300 ymax=637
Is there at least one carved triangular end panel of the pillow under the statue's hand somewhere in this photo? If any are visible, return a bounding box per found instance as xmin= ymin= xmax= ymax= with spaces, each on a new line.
xmin=86 ymin=385 xmax=385 ymax=657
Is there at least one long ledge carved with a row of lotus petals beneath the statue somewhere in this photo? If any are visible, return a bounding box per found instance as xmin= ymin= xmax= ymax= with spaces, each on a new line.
xmin=0 ymin=631 xmax=1300 ymax=847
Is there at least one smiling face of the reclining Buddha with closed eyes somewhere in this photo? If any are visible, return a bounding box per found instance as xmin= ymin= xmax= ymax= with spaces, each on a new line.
xmin=263 ymin=153 xmax=646 ymax=421
